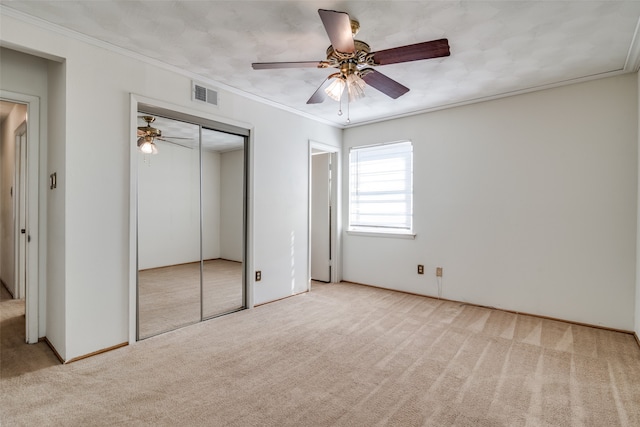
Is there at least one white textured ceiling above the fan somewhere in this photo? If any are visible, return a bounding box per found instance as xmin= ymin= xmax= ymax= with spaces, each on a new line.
xmin=2 ymin=0 xmax=640 ymax=127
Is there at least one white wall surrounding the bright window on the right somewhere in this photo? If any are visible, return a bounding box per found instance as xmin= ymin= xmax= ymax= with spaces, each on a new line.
xmin=343 ymin=75 xmax=638 ymax=330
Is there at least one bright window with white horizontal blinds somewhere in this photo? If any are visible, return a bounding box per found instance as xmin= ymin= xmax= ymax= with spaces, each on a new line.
xmin=349 ymin=141 xmax=413 ymax=234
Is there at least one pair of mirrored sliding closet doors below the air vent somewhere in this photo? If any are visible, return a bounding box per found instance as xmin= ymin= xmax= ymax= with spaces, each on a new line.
xmin=137 ymin=106 xmax=247 ymax=339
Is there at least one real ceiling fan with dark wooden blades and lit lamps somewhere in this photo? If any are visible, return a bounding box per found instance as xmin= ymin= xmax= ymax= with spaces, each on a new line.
xmin=251 ymin=9 xmax=450 ymax=108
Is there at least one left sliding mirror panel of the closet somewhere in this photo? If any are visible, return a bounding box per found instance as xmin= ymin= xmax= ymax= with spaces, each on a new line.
xmin=138 ymin=117 xmax=200 ymax=338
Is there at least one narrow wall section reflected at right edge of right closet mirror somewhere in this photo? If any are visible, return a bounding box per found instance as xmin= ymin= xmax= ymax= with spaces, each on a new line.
xmin=220 ymin=150 xmax=244 ymax=262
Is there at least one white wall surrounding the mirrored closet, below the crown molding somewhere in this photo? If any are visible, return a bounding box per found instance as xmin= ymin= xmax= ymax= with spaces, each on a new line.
xmin=0 ymin=11 xmax=341 ymax=360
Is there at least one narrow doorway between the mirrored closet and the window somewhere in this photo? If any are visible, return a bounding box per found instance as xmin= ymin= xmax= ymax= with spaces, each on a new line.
xmin=308 ymin=141 xmax=340 ymax=283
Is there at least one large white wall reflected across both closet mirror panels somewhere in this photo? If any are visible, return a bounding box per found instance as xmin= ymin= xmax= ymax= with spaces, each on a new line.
xmin=138 ymin=141 xmax=220 ymax=270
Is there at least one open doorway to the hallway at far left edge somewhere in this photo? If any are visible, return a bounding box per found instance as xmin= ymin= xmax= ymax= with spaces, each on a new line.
xmin=0 ymin=90 xmax=40 ymax=344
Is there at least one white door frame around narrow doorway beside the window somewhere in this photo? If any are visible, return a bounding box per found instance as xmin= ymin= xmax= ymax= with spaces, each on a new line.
xmin=307 ymin=140 xmax=342 ymax=291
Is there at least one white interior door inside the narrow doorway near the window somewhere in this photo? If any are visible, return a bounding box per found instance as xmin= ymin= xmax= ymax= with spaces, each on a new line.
xmin=311 ymin=153 xmax=331 ymax=282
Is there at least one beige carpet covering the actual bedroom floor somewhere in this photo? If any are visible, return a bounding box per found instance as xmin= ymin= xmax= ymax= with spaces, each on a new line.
xmin=0 ymin=283 xmax=640 ymax=427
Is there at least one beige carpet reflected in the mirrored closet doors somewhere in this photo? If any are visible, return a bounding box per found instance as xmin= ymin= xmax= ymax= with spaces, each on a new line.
xmin=138 ymin=259 xmax=244 ymax=338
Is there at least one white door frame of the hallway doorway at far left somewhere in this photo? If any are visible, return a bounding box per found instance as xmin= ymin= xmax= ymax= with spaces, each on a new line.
xmin=0 ymin=89 xmax=45 ymax=344
